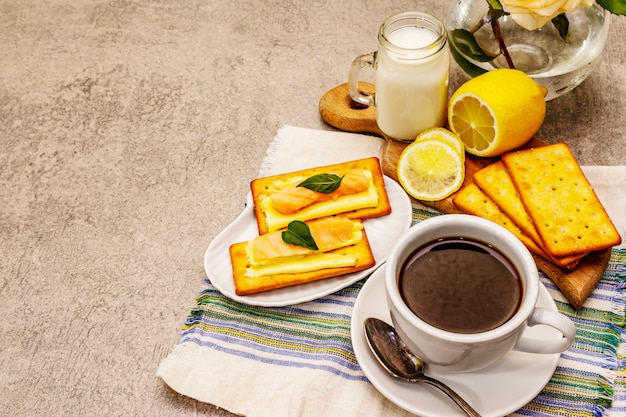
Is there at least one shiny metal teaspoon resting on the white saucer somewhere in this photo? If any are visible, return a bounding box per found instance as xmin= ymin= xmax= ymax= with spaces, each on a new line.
xmin=364 ymin=317 xmax=480 ymax=417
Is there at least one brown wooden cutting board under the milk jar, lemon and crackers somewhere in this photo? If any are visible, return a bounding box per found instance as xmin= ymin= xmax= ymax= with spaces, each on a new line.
xmin=319 ymin=82 xmax=611 ymax=309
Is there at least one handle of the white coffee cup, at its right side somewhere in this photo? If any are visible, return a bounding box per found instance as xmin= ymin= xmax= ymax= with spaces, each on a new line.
xmin=514 ymin=308 xmax=576 ymax=354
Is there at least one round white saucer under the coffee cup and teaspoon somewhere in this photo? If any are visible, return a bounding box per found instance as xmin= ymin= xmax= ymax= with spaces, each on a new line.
xmin=351 ymin=265 xmax=562 ymax=417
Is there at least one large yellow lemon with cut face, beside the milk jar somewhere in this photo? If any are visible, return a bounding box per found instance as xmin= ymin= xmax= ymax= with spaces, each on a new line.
xmin=448 ymin=68 xmax=547 ymax=156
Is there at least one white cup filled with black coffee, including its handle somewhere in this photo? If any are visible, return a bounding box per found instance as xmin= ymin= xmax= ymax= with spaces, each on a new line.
xmin=385 ymin=214 xmax=576 ymax=372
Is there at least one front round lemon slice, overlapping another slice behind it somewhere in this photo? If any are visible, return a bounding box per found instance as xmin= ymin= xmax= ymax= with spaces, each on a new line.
xmin=398 ymin=139 xmax=465 ymax=201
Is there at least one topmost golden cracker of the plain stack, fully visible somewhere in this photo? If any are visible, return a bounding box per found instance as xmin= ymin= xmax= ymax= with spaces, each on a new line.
xmin=502 ymin=143 xmax=621 ymax=257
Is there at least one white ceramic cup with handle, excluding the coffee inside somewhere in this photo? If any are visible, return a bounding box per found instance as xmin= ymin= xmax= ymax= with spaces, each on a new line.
xmin=385 ymin=214 xmax=576 ymax=372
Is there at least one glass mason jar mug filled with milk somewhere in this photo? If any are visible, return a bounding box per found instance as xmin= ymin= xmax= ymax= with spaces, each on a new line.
xmin=348 ymin=12 xmax=450 ymax=141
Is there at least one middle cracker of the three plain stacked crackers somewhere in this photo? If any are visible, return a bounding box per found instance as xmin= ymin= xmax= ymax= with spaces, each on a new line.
xmin=473 ymin=161 xmax=585 ymax=269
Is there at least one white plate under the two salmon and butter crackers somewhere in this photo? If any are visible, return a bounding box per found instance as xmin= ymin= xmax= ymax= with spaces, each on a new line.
xmin=204 ymin=177 xmax=413 ymax=307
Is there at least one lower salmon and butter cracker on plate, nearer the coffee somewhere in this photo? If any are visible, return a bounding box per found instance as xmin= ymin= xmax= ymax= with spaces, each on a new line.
xmin=230 ymin=216 xmax=376 ymax=295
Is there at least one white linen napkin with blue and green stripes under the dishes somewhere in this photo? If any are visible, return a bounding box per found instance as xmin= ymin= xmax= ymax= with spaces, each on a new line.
xmin=157 ymin=126 xmax=626 ymax=417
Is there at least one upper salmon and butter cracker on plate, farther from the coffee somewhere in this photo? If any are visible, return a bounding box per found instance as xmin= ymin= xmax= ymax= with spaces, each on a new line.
xmin=250 ymin=157 xmax=391 ymax=234
